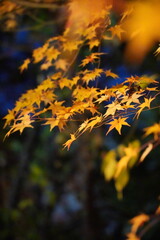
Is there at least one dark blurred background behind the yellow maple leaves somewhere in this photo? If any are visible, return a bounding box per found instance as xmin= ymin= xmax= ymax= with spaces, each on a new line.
xmin=0 ymin=2 xmax=160 ymax=240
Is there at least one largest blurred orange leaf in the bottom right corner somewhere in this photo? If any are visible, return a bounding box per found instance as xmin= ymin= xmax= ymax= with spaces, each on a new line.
xmin=130 ymin=213 xmax=150 ymax=233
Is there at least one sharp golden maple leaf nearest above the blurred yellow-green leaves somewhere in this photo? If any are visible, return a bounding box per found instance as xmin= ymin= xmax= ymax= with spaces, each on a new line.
xmin=106 ymin=117 xmax=130 ymax=135
